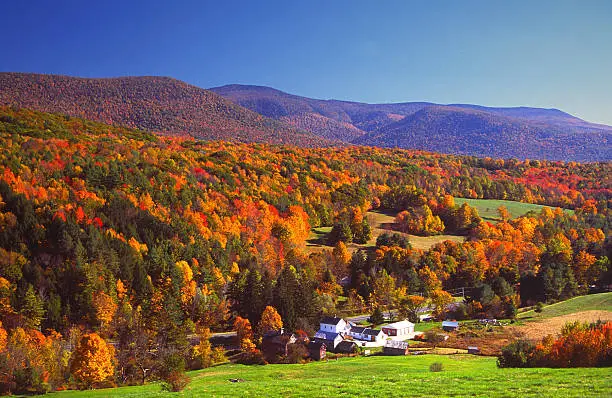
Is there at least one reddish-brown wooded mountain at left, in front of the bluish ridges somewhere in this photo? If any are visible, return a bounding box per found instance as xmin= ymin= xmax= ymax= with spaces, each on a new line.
xmin=0 ymin=73 xmax=329 ymax=146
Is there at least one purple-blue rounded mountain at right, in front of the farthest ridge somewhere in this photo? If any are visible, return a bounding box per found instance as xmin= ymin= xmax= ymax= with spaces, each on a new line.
xmin=355 ymin=106 xmax=612 ymax=161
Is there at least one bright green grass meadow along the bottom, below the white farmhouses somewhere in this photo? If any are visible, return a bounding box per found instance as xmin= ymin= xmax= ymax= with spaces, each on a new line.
xmin=53 ymin=355 xmax=612 ymax=397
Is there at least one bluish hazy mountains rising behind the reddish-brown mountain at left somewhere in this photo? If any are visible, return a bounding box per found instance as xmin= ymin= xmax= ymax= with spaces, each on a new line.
xmin=211 ymin=85 xmax=612 ymax=161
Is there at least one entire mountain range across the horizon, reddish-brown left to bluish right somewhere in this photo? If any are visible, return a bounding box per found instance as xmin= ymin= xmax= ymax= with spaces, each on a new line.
xmin=0 ymin=73 xmax=612 ymax=161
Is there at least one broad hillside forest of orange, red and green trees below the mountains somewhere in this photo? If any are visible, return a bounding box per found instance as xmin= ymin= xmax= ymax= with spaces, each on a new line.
xmin=0 ymin=107 xmax=612 ymax=391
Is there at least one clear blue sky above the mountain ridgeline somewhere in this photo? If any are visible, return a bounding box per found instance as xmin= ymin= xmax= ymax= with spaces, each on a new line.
xmin=0 ymin=0 xmax=612 ymax=125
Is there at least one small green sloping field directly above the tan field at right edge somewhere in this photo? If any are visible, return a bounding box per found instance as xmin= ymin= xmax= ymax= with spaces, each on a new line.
xmin=518 ymin=293 xmax=612 ymax=321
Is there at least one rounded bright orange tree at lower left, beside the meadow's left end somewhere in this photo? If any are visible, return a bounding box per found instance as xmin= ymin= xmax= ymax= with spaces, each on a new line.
xmin=70 ymin=333 xmax=115 ymax=387
